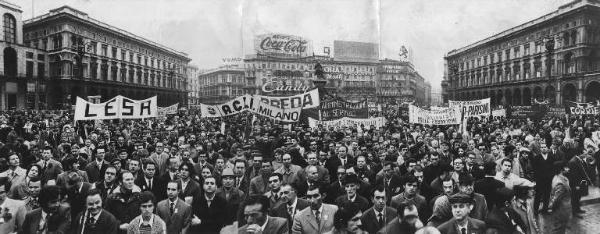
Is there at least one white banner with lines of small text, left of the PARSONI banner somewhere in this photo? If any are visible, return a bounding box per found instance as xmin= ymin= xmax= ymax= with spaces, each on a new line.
xmin=408 ymin=105 xmax=461 ymax=125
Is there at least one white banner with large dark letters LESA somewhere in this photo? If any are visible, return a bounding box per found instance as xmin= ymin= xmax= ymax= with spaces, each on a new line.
xmin=75 ymin=95 xmax=158 ymax=121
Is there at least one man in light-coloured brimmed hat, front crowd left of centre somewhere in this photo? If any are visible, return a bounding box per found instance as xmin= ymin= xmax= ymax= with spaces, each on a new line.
xmin=216 ymin=168 xmax=245 ymax=224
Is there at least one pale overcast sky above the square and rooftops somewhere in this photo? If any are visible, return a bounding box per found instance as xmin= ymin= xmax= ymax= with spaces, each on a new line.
xmin=18 ymin=0 xmax=570 ymax=89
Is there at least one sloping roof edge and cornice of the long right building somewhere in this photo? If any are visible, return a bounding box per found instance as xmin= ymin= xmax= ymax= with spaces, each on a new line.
xmin=446 ymin=0 xmax=600 ymax=57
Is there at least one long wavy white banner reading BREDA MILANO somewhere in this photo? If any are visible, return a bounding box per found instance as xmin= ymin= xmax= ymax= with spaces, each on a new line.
xmin=200 ymin=89 xmax=320 ymax=122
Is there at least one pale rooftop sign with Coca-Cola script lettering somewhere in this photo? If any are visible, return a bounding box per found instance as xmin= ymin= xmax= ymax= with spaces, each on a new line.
xmin=254 ymin=34 xmax=312 ymax=57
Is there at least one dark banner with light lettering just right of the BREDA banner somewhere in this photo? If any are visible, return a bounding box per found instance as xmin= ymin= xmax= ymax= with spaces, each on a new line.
xmin=321 ymin=98 xmax=369 ymax=121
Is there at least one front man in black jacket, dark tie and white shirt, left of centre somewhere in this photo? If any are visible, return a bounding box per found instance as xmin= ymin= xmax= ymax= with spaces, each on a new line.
xmin=188 ymin=176 xmax=227 ymax=234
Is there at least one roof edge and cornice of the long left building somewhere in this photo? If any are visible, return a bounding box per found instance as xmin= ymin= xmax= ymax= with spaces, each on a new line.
xmin=24 ymin=5 xmax=188 ymax=57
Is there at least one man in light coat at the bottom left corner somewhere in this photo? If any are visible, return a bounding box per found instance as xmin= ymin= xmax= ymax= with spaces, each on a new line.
xmin=0 ymin=177 xmax=27 ymax=233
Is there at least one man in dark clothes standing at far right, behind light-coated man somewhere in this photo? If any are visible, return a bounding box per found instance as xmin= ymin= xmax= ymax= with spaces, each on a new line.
xmin=568 ymin=145 xmax=598 ymax=218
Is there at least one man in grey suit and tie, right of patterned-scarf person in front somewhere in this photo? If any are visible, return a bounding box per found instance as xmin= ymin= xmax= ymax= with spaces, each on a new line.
xmin=156 ymin=181 xmax=192 ymax=234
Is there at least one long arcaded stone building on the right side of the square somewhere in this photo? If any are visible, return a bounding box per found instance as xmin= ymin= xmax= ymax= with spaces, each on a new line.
xmin=442 ymin=0 xmax=600 ymax=106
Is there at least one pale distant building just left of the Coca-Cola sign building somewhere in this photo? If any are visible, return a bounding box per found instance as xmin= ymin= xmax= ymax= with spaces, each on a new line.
xmin=198 ymin=65 xmax=246 ymax=104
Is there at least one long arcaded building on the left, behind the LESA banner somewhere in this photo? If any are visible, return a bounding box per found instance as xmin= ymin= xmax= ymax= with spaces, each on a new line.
xmin=22 ymin=6 xmax=190 ymax=109
